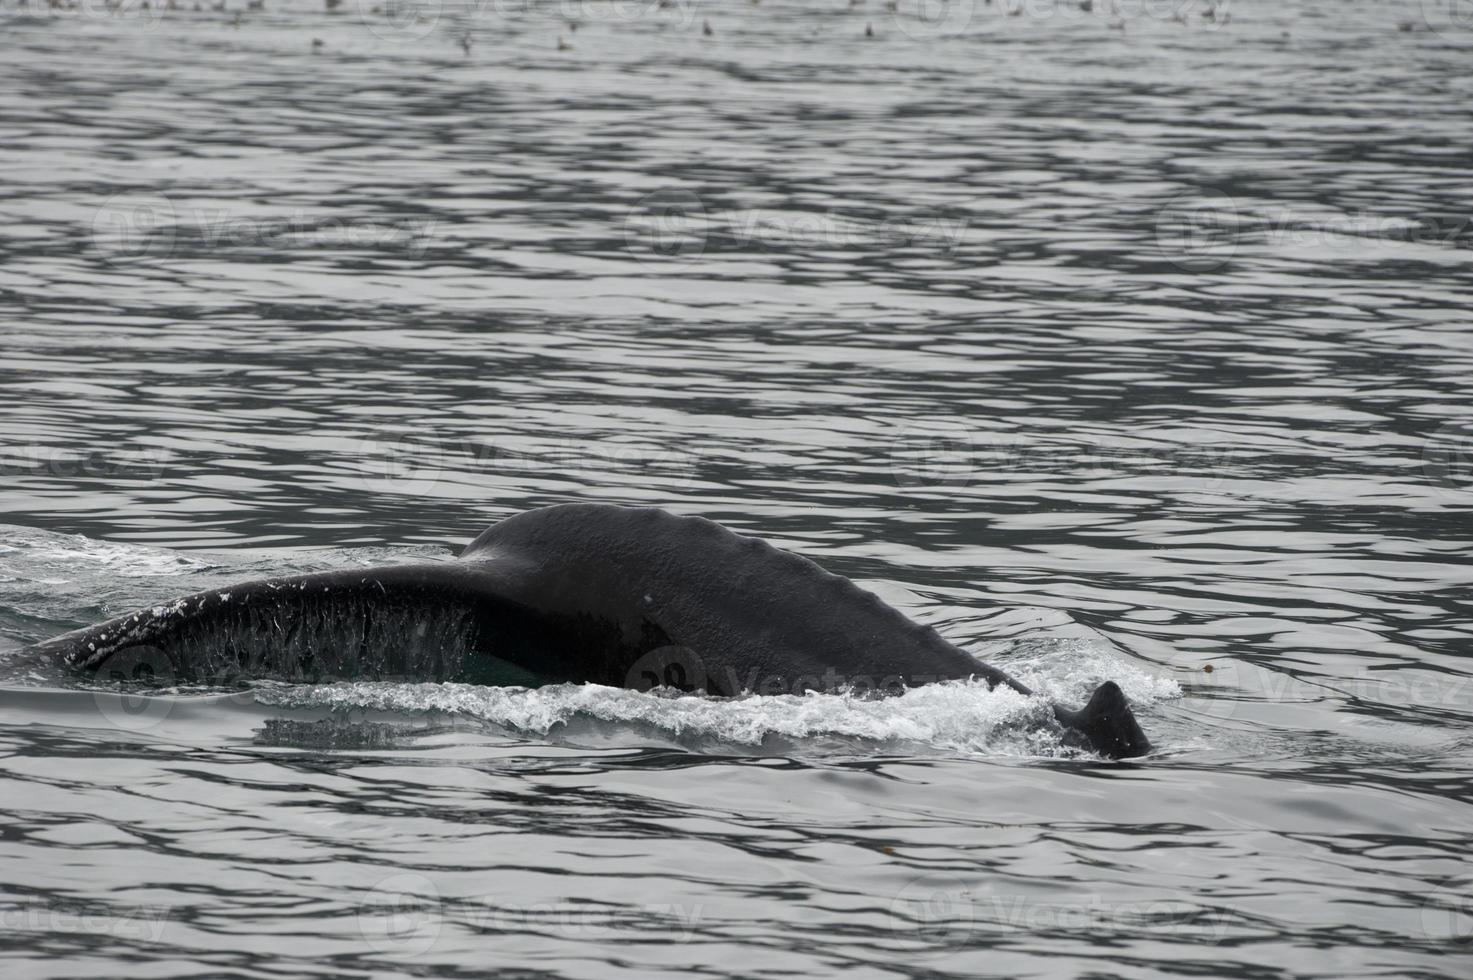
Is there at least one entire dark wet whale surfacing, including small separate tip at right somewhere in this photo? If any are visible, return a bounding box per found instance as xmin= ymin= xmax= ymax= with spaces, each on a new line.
xmin=31 ymin=504 xmax=1150 ymax=757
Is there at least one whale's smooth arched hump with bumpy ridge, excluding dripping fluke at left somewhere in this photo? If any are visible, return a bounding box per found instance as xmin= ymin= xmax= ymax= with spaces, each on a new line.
xmin=461 ymin=504 xmax=1003 ymax=694
